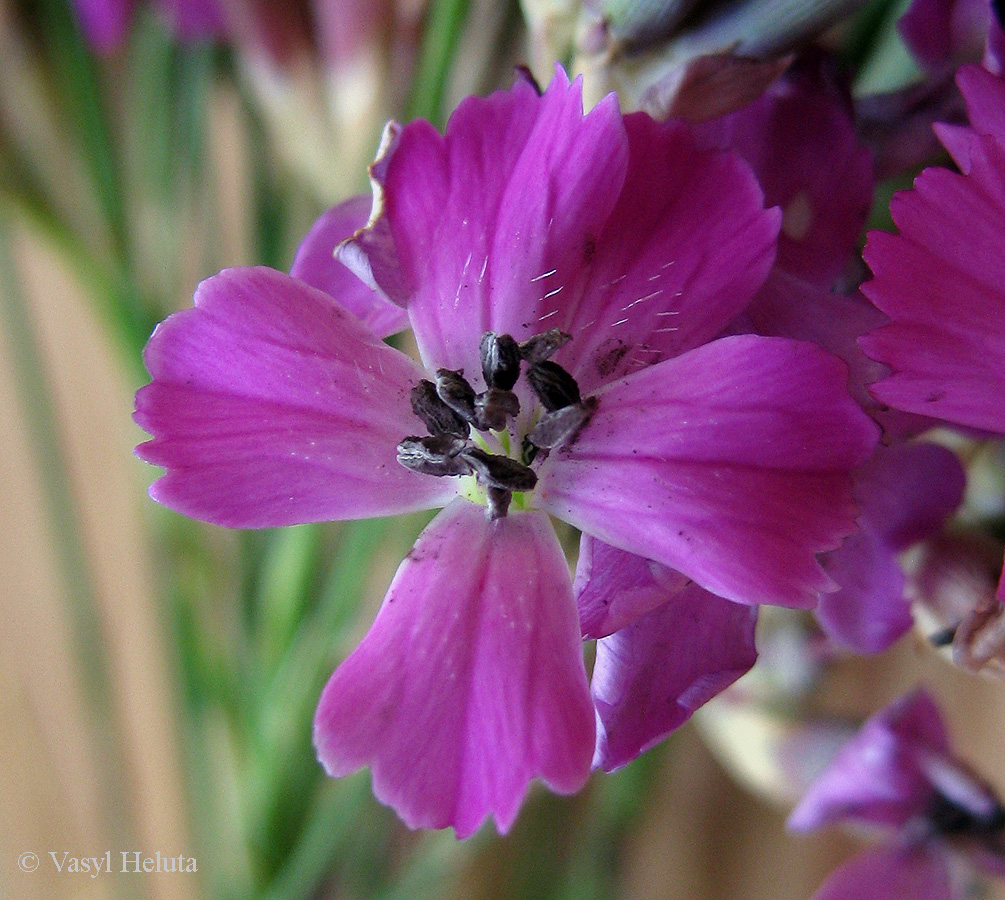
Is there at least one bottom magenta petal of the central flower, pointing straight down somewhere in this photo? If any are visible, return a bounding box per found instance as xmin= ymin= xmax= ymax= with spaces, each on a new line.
xmin=315 ymin=500 xmax=594 ymax=838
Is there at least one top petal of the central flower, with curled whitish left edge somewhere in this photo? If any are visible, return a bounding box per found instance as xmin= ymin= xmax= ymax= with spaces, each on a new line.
xmin=340 ymin=69 xmax=628 ymax=377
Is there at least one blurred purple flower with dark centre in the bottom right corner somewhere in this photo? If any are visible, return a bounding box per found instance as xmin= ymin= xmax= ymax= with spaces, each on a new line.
xmin=789 ymin=690 xmax=1005 ymax=900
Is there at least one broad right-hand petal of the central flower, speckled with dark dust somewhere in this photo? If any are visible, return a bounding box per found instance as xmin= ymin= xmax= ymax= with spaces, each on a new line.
xmin=537 ymin=335 xmax=878 ymax=607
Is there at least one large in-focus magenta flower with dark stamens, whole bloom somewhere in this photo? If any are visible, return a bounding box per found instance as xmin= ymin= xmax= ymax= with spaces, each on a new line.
xmin=137 ymin=70 xmax=876 ymax=837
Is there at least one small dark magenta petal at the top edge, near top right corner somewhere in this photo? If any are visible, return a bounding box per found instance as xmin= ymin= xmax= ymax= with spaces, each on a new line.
xmin=896 ymin=0 xmax=991 ymax=69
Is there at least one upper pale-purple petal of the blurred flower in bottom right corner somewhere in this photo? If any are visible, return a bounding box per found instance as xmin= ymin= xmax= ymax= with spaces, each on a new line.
xmin=788 ymin=690 xmax=949 ymax=831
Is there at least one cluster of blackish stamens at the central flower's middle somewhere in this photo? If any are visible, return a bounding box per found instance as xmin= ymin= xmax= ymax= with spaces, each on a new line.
xmin=398 ymin=328 xmax=597 ymax=518
